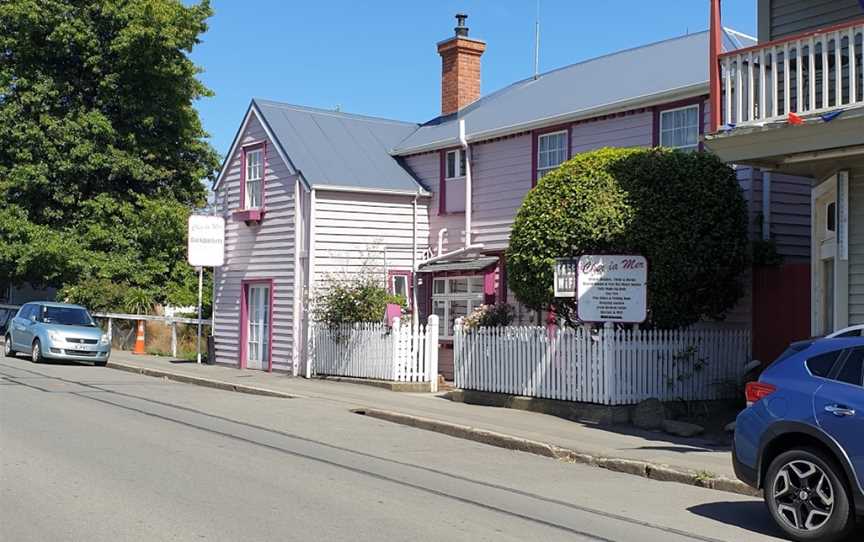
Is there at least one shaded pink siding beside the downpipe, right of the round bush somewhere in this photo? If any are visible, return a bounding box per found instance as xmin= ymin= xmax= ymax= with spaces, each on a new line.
xmin=738 ymin=167 xmax=813 ymax=263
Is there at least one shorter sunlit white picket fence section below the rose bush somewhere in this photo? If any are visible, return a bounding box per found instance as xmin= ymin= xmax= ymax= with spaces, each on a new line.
xmin=310 ymin=315 xmax=438 ymax=392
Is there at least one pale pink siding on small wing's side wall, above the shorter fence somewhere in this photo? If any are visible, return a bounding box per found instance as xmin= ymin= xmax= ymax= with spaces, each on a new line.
xmin=314 ymin=189 xmax=429 ymax=289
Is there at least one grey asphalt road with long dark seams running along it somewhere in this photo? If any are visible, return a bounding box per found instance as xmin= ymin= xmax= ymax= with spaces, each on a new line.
xmin=0 ymin=358 xmax=796 ymax=542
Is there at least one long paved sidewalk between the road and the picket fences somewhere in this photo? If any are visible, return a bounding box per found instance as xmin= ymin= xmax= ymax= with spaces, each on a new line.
xmin=108 ymin=351 xmax=753 ymax=495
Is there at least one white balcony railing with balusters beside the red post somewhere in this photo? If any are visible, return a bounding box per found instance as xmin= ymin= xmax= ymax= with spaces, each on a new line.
xmin=714 ymin=19 xmax=864 ymax=127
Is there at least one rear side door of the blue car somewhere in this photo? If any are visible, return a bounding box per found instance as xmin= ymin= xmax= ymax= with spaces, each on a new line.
xmin=813 ymin=348 xmax=864 ymax=492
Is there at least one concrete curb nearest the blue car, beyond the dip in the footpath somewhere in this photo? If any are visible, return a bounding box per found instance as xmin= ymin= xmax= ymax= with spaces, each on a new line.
xmin=352 ymin=408 xmax=761 ymax=497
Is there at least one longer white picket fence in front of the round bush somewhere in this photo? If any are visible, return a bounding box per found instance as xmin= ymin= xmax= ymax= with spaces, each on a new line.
xmin=453 ymin=325 xmax=750 ymax=405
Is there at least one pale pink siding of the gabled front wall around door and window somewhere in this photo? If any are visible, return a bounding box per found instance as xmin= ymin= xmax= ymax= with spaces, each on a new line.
xmin=213 ymin=114 xmax=297 ymax=371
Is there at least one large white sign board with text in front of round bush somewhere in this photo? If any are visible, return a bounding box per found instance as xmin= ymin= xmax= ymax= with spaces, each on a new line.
xmin=576 ymin=254 xmax=648 ymax=324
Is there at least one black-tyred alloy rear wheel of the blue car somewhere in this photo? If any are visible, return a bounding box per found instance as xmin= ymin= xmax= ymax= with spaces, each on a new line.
xmin=764 ymin=448 xmax=855 ymax=542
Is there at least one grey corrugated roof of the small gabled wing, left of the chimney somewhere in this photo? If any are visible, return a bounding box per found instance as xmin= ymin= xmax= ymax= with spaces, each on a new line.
xmin=252 ymin=98 xmax=420 ymax=191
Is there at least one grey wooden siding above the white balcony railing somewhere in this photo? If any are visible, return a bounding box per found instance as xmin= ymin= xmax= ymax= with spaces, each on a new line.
xmin=759 ymin=0 xmax=864 ymax=42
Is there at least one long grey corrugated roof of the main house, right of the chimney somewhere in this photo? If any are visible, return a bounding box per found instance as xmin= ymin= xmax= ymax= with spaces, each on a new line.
xmin=393 ymin=29 xmax=756 ymax=154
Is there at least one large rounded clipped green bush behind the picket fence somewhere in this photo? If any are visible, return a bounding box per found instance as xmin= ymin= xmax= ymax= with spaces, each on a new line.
xmin=507 ymin=149 xmax=749 ymax=328
